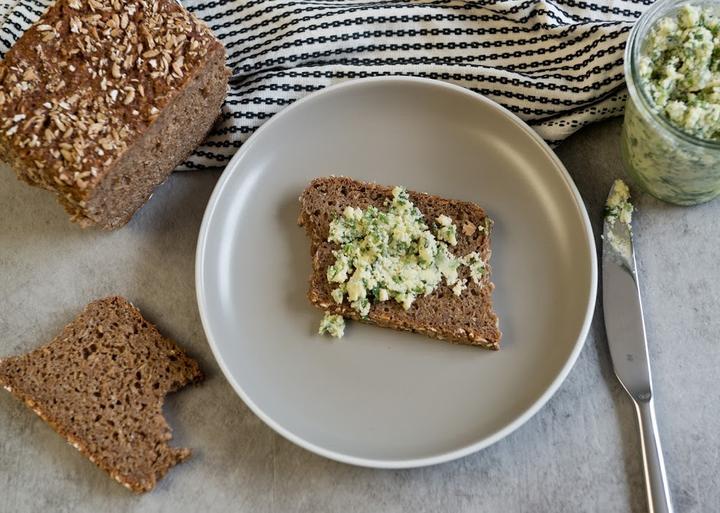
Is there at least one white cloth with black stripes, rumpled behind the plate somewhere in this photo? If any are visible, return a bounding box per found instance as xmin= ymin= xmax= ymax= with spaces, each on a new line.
xmin=0 ymin=0 xmax=653 ymax=169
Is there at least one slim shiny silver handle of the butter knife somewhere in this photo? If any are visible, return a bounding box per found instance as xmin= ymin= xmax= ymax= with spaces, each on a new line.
xmin=633 ymin=397 xmax=673 ymax=513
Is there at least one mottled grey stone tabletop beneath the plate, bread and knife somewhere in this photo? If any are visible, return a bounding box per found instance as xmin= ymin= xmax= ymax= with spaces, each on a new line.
xmin=0 ymin=120 xmax=720 ymax=513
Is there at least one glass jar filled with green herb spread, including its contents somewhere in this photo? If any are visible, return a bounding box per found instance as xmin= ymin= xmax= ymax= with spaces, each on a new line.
xmin=622 ymin=0 xmax=720 ymax=205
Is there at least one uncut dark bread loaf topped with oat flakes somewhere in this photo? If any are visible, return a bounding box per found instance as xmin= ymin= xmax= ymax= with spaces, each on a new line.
xmin=0 ymin=0 xmax=229 ymax=228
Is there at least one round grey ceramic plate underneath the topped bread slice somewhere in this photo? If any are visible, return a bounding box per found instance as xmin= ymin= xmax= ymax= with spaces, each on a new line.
xmin=196 ymin=78 xmax=597 ymax=468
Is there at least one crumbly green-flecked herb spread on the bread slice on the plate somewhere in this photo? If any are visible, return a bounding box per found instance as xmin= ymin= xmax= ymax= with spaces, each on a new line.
xmin=321 ymin=187 xmax=487 ymax=338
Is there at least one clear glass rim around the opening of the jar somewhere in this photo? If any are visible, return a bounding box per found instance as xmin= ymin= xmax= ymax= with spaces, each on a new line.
xmin=625 ymin=0 xmax=720 ymax=149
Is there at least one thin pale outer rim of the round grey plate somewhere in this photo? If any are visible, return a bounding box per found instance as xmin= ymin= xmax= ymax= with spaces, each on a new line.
xmin=195 ymin=76 xmax=598 ymax=469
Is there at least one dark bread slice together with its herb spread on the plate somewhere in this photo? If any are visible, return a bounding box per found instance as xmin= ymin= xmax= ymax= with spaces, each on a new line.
xmin=298 ymin=177 xmax=501 ymax=349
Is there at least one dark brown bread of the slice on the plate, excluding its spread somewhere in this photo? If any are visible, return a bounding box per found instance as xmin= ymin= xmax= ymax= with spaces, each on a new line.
xmin=298 ymin=177 xmax=501 ymax=349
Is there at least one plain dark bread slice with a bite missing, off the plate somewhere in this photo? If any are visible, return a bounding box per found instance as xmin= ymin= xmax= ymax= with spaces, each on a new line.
xmin=0 ymin=297 xmax=203 ymax=492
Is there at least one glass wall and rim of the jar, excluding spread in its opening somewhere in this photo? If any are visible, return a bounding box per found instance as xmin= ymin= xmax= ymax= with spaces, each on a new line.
xmin=622 ymin=0 xmax=720 ymax=205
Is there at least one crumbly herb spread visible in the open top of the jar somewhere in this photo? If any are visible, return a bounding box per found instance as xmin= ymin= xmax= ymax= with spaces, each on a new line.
xmin=638 ymin=5 xmax=720 ymax=140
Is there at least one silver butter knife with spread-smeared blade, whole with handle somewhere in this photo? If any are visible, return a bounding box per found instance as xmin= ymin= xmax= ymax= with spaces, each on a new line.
xmin=602 ymin=180 xmax=673 ymax=513
